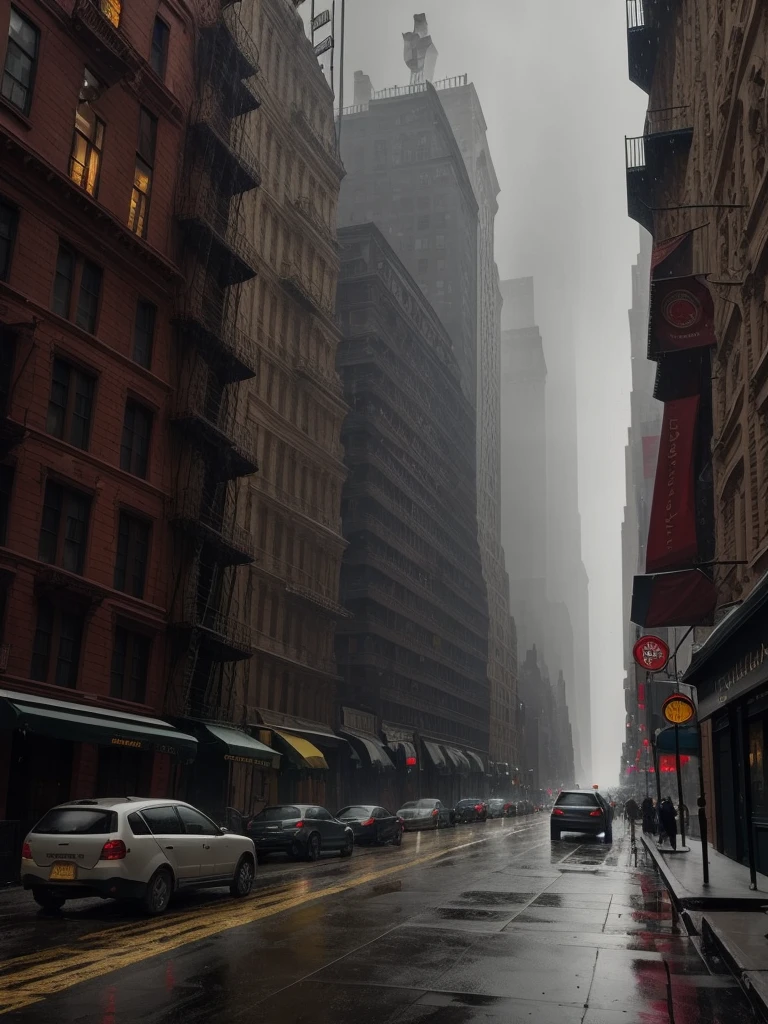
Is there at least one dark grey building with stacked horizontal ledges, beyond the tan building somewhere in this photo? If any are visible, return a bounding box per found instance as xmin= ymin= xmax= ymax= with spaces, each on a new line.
xmin=337 ymin=224 xmax=489 ymax=806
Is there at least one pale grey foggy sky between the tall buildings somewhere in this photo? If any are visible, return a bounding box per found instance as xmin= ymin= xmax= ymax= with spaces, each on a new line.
xmin=302 ymin=0 xmax=647 ymax=785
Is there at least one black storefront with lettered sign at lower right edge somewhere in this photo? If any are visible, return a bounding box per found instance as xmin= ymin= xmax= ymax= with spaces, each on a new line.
xmin=683 ymin=574 xmax=768 ymax=874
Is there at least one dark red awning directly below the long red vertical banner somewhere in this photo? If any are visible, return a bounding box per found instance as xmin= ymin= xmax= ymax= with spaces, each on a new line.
xmin=630 ymin=569 xmax=718 ymax=629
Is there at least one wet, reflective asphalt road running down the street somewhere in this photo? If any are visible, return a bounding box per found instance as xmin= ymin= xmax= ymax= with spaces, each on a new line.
xmin=0 ymin=815 xmax=754 ymax=1024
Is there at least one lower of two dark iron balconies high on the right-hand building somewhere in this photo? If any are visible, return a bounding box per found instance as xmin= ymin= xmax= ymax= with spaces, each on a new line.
xmin=625 ymin=106 xmax=693 ymax=233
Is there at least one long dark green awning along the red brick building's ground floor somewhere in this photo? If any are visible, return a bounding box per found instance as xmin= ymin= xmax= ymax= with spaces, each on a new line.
xmin=0 ymin=690 xmax=198 ymax=761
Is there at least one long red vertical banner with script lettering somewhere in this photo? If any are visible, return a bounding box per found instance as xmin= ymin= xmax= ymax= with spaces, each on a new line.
xmin=645 ymin=395 xmax=699 ymax=572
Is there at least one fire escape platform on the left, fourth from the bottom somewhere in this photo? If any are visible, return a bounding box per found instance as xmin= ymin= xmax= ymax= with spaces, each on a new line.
xmin=174 ymin=291 xmax=257 ymax=384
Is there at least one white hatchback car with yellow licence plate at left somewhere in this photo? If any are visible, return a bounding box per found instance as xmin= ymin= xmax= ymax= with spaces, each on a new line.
xmin=22 ymin=797 xmax=256 ymax=914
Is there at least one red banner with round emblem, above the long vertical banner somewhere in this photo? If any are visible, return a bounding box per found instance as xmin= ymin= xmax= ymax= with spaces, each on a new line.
xmin=650 ymin=278 xmax=717 ymax=355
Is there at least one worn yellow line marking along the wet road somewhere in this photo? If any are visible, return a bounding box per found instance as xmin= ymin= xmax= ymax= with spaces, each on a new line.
xmin=0 ymin=825 xmax=535 ymax=1016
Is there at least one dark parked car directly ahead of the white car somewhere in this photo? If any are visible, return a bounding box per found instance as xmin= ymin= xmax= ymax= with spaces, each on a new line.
xmin=248 ymin=804 xmax=354 ymax=860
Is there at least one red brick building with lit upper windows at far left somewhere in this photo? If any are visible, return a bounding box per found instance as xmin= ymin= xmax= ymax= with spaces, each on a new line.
xmin=0 ymin=0 xmax=220 ymax=843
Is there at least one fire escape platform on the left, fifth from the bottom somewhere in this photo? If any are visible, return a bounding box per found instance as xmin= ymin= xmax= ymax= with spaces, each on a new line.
xmin=177 ymin=191 xmax=260 ymax=287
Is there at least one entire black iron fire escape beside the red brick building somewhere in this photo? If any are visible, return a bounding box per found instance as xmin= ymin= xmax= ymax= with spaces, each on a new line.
xmin=169 ymin=0 xmax=261 ymax=721
